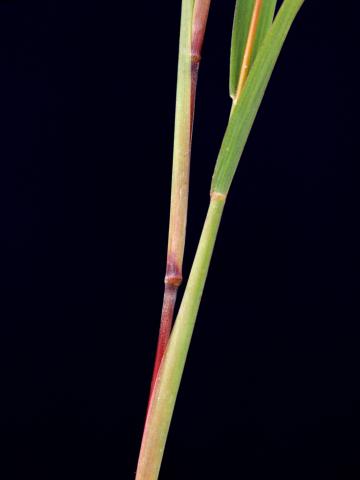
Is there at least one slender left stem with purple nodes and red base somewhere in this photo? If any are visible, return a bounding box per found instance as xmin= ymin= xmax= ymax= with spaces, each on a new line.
xmin=149 ymin=0 xmax=211 ymax=401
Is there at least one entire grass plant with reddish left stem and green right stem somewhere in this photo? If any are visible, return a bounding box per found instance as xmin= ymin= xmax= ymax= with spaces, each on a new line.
xmin=136 ymin=0 xmax=304 ymax=480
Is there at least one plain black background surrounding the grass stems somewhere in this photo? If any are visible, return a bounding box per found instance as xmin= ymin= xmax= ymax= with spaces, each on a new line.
xmin=0 ymin=0 xmax=360 ymax=480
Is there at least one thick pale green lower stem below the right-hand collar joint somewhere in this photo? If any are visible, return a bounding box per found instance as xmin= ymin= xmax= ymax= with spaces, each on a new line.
xmin=136 ymin=194 xmax=225 ymax=480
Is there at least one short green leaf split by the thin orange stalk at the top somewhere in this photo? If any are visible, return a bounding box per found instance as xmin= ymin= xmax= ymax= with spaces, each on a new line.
xmin=229 ymin=0 xmax=276 ymax=99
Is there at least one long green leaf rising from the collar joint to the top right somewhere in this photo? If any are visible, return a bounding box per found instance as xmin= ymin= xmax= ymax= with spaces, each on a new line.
xmin=211 ymin=0 xmax=304 ymax=195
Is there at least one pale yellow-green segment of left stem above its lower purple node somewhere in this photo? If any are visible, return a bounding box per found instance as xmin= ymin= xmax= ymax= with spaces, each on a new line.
xmin=167 ymin=0 xmax=194 ymax=276
